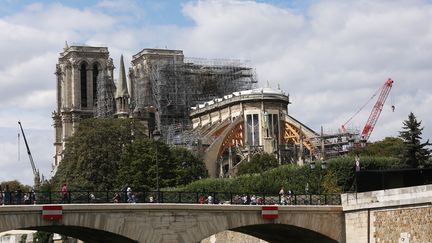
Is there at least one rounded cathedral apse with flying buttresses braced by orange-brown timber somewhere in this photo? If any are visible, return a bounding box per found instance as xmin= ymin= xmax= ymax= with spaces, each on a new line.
xmin=190 ymin=88 xmax=317 ymax=177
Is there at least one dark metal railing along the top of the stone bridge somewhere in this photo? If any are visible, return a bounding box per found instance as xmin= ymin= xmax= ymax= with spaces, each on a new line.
xmin=0 ymin=191 xmax=341 ymax=205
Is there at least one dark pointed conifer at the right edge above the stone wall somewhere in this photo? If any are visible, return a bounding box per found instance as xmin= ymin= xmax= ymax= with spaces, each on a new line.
xmin=399 ymin=112 xmax=431 ymax=168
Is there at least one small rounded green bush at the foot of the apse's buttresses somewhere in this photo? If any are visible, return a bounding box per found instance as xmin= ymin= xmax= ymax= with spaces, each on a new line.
xmin=238 ymin=153 xmax=279 ymax=175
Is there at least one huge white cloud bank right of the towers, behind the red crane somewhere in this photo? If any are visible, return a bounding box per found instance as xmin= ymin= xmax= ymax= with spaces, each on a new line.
xmin=176 ymin=1 xmax=432 ymax=143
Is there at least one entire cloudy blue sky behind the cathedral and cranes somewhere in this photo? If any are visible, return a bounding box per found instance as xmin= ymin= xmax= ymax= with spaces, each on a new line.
xmin=0 ymin=0 xmax=432 ymax=184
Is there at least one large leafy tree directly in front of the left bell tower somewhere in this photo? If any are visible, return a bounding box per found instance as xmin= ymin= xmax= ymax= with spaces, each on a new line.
xmin=52 ymin=118 xmax=146 ymax=190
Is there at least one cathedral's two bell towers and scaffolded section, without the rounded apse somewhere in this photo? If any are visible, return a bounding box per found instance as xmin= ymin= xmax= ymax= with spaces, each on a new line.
xmin=53 ymin=43 xmax=257 ymax=173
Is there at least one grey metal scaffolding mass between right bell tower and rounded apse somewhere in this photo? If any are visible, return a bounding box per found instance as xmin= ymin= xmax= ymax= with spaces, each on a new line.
xmin=131 ymin=53 xmax=257 ymax=145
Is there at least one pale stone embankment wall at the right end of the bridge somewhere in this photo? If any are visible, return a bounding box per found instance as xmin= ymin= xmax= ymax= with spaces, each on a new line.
xmin=342 ymin=185 xmax=432 ymax=243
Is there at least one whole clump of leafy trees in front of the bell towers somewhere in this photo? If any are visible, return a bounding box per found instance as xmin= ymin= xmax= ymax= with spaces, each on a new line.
xmin=51 ymin=118 xmax=207 ymax=190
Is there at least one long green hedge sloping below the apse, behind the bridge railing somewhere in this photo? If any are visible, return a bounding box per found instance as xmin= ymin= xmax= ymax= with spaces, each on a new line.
xmin=177 ymin=156 xmax=402 ymax=194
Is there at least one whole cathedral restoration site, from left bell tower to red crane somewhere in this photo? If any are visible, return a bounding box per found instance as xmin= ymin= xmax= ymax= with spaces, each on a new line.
xmin=53 ymin=45 xmax=393 ymax=177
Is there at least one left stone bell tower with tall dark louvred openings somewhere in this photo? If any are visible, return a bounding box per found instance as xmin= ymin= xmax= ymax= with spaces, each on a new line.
xmin=52 ymin=43 xmax=115 ymax=173
